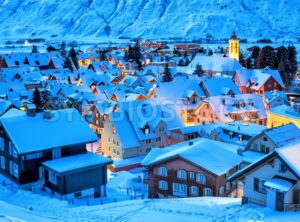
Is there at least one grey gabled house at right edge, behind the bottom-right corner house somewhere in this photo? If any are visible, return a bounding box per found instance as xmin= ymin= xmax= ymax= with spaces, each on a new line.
xmin=245 ymin=123 xmax=300 ymax=153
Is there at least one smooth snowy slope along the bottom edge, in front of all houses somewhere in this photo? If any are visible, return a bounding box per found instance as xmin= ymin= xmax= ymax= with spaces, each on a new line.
xmin=0 ymin=194 xmax=300 ymax=222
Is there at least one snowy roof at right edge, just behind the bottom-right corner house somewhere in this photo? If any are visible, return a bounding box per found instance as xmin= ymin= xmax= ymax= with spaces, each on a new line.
xmin=264 ymin=123 xmax=300 ymax=147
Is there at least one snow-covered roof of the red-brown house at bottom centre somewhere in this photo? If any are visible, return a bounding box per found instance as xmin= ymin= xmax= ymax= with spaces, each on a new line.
xmin=141 ymin=138 xmax=242 ymax=176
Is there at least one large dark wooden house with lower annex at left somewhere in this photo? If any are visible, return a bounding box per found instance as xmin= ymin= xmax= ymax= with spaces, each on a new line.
xmin=0 ymin=107 xmax=112 ymax=197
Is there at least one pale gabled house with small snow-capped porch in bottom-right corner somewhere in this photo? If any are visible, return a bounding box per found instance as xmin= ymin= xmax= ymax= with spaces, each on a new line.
xmin=228 ymin=144 xmax=300 ymax=211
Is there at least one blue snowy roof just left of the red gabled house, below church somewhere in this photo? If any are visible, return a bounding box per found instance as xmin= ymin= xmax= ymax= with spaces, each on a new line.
xmin=200 ymin=77 xmax=241 ymax=96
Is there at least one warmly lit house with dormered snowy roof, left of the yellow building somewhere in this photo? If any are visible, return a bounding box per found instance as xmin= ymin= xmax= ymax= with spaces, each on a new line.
xmin=195 ymin=94 xmax=267 ymax=125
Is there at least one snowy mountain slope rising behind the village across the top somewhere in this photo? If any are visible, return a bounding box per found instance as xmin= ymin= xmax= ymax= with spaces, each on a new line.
xmin=0 ymin=0 xmax=300 ymax=39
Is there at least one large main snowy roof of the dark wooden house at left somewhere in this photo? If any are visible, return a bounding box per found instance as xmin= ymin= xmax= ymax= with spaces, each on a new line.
xmin=0 ymin=109 xmax=98 ymax=154
